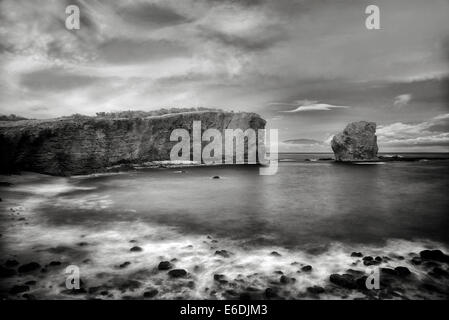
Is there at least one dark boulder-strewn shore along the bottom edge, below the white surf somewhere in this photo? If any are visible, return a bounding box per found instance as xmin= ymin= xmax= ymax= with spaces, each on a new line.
xmin=0 ymin=232 xmax=449 ymax=300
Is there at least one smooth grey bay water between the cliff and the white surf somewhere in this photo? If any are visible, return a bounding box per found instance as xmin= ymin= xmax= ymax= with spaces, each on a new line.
xmin=31 ymin=157 xmax=449 ymax=247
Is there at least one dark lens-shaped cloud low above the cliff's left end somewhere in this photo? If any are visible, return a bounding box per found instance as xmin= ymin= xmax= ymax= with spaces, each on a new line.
xmin=21 ymin=68 xmax=101 ymax=92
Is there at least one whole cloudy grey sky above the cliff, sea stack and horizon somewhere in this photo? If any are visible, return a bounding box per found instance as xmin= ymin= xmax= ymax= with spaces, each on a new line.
xmin=0 ymin=0 xmax=449 ymax=152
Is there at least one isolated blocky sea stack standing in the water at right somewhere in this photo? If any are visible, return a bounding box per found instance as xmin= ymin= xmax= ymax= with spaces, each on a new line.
xmin=331 ymin=121 xmax=378 ymax=161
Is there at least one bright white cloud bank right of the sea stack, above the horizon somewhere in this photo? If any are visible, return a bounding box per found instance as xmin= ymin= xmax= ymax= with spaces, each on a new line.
xmin=376 ymin=113 xmax=449 ymax=147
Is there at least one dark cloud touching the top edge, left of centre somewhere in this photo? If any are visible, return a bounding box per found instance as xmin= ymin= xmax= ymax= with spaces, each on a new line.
xmin=117 ymin=3 xmax=192 ymax=28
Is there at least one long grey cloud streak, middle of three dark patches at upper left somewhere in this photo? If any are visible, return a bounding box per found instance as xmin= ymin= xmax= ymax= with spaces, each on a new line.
xmin=98 ymin=38 xmax=190 ymax=64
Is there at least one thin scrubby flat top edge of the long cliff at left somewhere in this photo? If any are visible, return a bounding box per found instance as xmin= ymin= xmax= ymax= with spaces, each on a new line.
xmin=0 ymin=110 xmax=262 ymax=129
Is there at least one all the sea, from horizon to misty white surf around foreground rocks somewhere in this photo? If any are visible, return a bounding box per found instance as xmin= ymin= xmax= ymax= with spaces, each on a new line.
xmin=0 ymin=154 xmax=449 ymax=299
